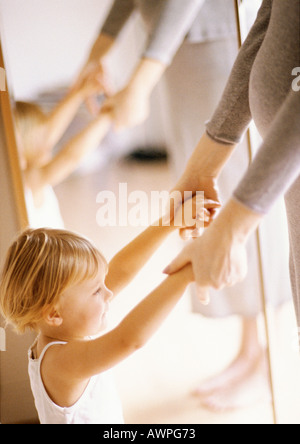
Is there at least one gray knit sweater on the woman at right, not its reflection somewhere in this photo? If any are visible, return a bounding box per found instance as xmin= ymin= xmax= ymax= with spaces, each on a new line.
xmin=207 ymin=0 xmax=300 ymax=214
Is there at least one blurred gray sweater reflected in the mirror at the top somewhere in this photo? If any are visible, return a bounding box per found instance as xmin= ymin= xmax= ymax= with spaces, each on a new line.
xmin=101 ymin=0 xmax=237 ymax=65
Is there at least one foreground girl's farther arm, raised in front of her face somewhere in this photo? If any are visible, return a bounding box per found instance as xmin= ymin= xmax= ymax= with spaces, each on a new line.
xmin=105 ymin=220 xmax=175 ymax=296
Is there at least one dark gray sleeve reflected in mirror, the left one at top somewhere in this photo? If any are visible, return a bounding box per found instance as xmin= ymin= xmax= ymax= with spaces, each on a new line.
xmin=101 ymin=0 xmax=135 ymax=38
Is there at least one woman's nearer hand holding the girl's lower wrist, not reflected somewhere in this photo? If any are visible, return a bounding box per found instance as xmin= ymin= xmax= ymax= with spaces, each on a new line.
xmin=164 ymin=199 xmax=262 ymax=304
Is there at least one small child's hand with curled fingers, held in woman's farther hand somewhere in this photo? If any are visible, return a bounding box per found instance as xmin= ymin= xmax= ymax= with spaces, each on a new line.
xmin=173 ymin=194 xmax=215 ymax=239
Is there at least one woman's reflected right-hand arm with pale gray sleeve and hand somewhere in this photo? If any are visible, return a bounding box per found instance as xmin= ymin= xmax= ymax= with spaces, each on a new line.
xmin=103 ymin=0 xmax=204 ymax=130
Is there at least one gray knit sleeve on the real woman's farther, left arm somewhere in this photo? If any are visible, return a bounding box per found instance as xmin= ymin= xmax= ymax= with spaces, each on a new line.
xmin=206 ymin=0 xmax=272 ymax=144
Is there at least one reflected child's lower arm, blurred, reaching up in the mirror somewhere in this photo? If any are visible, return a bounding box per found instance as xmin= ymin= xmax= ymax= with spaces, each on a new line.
xmin=25 ymin=114 xmax=111 ymax=192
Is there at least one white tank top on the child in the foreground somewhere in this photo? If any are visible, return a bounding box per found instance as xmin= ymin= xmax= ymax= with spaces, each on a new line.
xmin=28 ymin=342 xmax=124 ymax=424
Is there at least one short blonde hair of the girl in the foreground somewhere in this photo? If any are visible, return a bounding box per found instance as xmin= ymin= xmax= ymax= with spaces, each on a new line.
xmin=0 ymin=228 xmax=107 ymax=333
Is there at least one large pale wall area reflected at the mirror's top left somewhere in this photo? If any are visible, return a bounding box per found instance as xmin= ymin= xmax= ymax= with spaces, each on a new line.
xmin=0 ymin=0 xmax=111 ymax=100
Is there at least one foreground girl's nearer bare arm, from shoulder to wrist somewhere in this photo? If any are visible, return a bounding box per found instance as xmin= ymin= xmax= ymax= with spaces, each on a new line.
xmin=53 ymin=265 xmax=194 ymax=384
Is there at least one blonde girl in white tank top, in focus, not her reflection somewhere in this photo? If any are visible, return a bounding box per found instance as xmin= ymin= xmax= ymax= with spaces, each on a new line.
xmin=0 ymin=199 xmax=209 ymax=424
